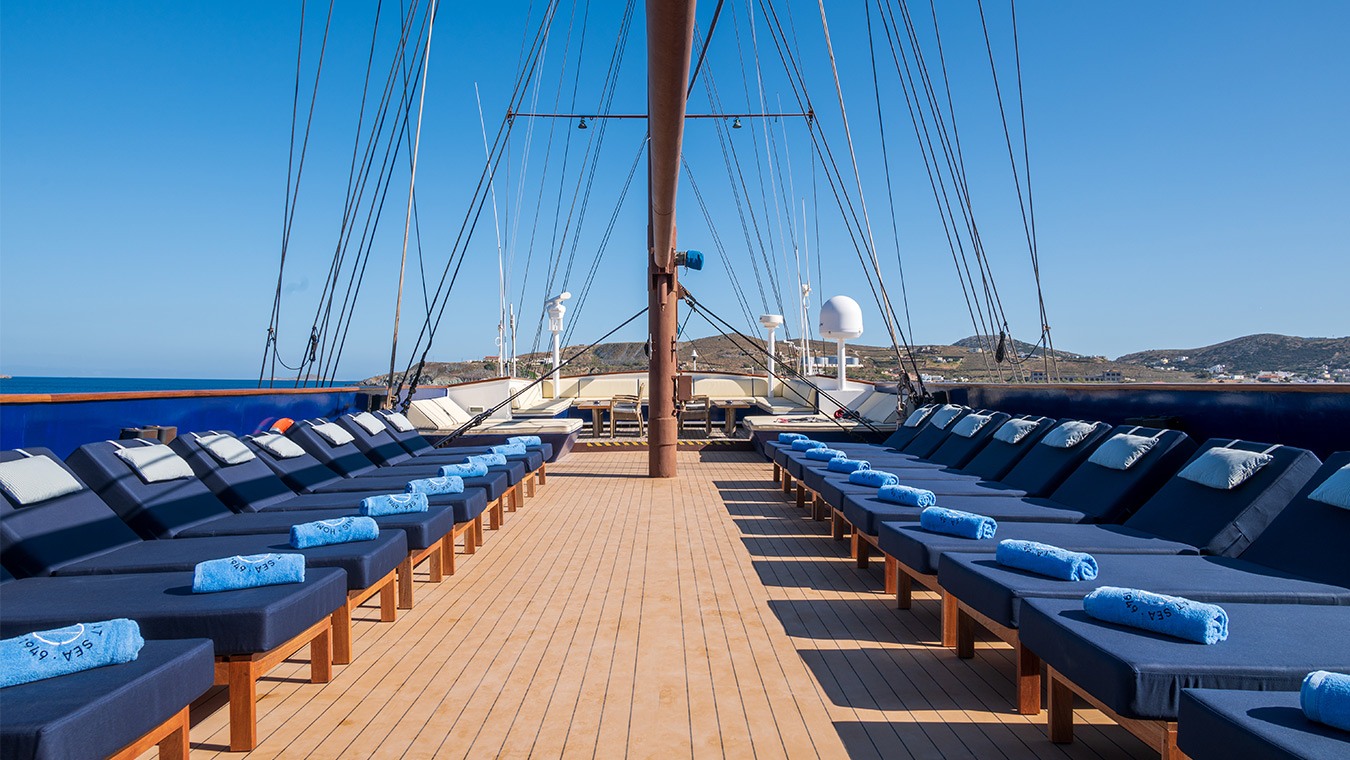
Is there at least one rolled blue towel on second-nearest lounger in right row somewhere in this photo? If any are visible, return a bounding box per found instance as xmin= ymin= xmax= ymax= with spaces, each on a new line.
xmin=1083 ymin=586 xmax=1229 ymax=644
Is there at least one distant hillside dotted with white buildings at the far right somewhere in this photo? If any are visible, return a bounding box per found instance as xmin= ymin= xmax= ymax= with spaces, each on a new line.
xmin=1116 ymin=333 xmax=1350 ymax=374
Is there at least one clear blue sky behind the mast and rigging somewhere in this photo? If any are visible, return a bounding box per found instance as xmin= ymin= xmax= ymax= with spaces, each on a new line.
xmin=0 ymin=0 xmax=1350 ymax=377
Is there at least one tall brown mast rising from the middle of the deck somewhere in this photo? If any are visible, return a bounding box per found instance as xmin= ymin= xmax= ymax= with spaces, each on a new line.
xmin=647 ymin=0 xmax=695 ymax=478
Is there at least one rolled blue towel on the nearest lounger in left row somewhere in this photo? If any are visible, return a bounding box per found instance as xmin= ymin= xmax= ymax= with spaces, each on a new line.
xmin=0 ymin=617 xmax=146 ymax=688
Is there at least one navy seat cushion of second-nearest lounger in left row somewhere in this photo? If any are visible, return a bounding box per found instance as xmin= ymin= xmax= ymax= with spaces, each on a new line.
xmin=0 ymin=567 xmax=347 ymax=656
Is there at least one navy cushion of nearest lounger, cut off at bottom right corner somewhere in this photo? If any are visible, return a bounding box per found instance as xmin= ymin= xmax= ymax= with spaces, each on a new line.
xmin=1177 ymin=688 xmax=1350 ymax=760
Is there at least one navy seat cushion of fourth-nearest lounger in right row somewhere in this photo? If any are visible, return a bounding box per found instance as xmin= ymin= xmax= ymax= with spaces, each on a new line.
xmin=878 ymin=522 xmax=1199 ymax=574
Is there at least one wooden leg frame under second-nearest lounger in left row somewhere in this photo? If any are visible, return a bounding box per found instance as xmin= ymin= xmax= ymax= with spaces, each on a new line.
xmin=215 ymin=607 xmax=334 ymax=752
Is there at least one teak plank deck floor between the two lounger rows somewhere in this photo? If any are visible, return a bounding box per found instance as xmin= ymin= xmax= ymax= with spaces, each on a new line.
xmin=176 ymin=450 xmax=1156 ymax=759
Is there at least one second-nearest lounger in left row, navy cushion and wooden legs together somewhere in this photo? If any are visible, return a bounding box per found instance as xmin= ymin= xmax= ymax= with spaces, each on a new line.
xmin=0 ymin=566 xmax=347 ymax=752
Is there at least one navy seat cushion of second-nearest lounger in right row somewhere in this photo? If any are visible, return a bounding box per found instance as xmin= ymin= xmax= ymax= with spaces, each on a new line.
xmin=1021 ymin=599 xmax=1350 ymax=720
